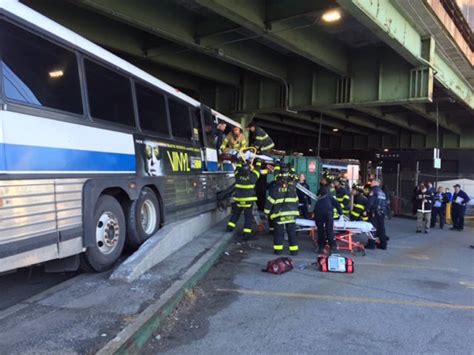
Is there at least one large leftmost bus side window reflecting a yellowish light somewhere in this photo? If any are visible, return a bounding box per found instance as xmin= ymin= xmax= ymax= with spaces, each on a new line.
xmin=0 ymin=20 xmax=83 ymax=115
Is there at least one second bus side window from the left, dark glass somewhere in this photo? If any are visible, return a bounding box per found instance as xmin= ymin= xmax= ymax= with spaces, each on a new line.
xmin=84 ymin=59 xmax=135 ymax=127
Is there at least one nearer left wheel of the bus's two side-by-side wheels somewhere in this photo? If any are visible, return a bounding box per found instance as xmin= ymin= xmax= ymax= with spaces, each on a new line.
xmin=81 ymin=195 xmax=126 ymax=272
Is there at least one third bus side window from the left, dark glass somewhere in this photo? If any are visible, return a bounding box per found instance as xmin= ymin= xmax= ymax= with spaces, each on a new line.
xmin=135 ymin=83 xmax=170 ymax=136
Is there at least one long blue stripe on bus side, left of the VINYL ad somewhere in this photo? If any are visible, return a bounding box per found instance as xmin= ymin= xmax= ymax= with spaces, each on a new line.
xmin=0 ymin=144 xmax=136 ymax=172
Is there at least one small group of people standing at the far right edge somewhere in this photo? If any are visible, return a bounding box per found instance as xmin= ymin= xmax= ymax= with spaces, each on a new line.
xmin=413 ymin=182 xmax=470 ymax=233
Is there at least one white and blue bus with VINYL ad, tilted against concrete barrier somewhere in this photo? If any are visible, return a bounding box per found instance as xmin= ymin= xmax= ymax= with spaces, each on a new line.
xmin=0 ymin=0 xmax=238 ymax=273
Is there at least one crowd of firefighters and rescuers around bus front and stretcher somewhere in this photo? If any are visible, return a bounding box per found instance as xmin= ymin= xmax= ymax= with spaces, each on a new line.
xmin=222 ymin=123 xmax=389 ymax=255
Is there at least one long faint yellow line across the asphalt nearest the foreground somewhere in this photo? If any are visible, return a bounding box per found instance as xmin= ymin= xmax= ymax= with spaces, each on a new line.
xmin=216 ymin=288 xmax=474 ymax=311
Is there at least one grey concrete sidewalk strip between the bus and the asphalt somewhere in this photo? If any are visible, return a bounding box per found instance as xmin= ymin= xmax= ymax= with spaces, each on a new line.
xmin=0 ymin=221 xmax=233 ymax=355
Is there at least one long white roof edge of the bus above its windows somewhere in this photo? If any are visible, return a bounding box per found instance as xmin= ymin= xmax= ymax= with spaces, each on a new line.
xmin=0 ymin=0 xmax=240 ymax=127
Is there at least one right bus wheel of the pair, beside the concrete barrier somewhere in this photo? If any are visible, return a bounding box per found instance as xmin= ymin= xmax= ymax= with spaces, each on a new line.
xmin=126 ymin=187 xmax=161 ymax=249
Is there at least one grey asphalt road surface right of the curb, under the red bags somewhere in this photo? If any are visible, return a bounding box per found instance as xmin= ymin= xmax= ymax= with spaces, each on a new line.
xmin=144 ymin=219 xmax=474 ymax=354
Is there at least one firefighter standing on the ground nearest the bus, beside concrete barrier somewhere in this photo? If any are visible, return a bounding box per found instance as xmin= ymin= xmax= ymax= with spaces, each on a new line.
xmin=227 ymin=162 xmax=260 ymax=238
